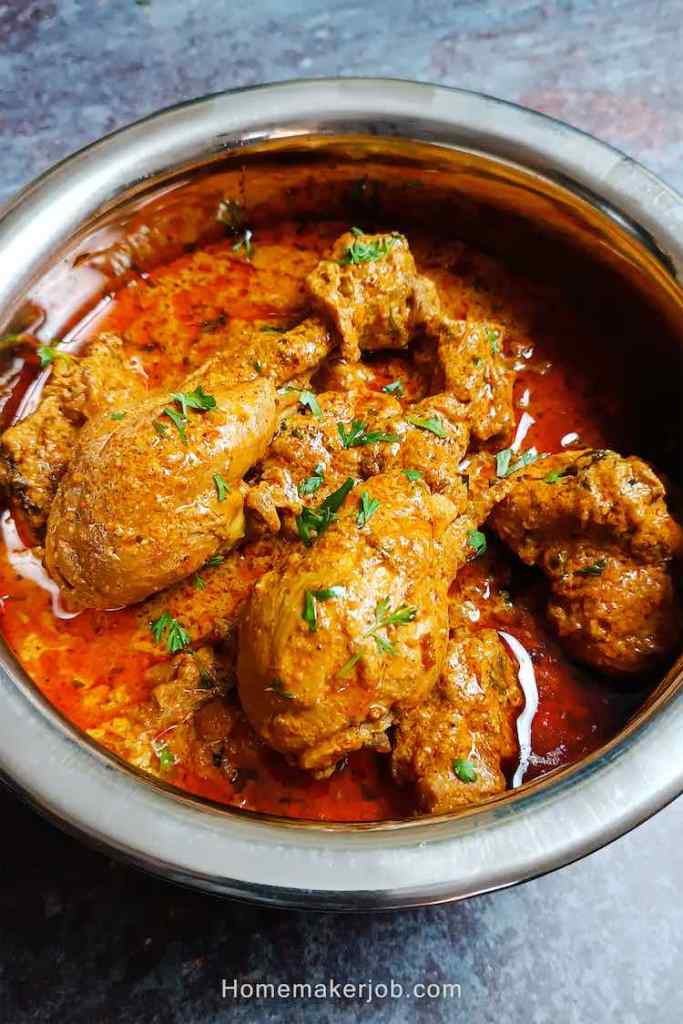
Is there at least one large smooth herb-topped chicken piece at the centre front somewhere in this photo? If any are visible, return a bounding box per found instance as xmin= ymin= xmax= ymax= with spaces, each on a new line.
xmin=238 ymin=472 xmax=457 ymax=776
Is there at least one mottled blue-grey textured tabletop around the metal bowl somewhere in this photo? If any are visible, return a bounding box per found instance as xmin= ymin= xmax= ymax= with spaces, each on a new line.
xmin=0 ymin=0 xmax=683 ymax=1024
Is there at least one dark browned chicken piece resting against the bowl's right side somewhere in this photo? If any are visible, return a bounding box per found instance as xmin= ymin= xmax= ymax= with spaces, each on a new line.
xmin=490 ymin=451 xmax=683 ymax=676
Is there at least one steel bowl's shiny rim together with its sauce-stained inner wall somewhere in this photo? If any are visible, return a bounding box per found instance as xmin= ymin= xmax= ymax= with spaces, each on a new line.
xmin=0 ymin=80 xmax=683 ymax=909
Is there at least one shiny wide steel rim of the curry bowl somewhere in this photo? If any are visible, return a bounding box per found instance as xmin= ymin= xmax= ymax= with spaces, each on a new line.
xmin=0 ymin=78 xmax=683 ymax=909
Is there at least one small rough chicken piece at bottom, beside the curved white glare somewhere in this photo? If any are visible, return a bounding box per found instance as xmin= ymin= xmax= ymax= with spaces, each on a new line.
xmin=391 ymin=629 xmax=523 ymax=814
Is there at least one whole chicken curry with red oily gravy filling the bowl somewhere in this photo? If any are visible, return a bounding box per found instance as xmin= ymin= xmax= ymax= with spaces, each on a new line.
xmin=0 ymin=167 xmax=683 ymax=821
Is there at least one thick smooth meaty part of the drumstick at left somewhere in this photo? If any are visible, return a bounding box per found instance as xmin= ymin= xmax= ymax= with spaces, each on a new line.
xmin=45 ymin=374 xmax=276 ymax=608
